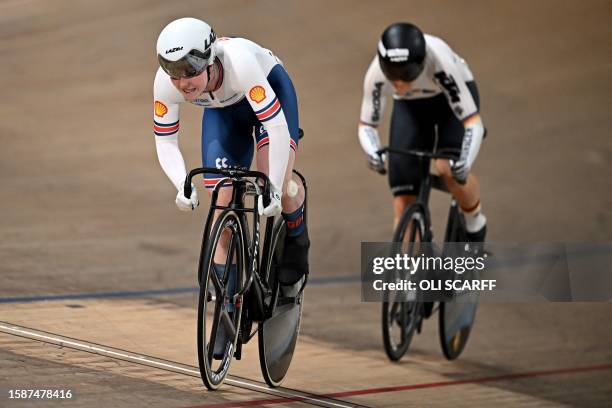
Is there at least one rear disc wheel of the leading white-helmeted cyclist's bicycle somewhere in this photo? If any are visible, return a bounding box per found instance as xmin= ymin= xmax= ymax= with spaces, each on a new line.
xmin=258 ymin=220 xmax=305 ymax=387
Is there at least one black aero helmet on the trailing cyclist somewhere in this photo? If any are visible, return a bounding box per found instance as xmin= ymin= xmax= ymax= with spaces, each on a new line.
xmin=378 ymin=23 xmax=425 ymax=82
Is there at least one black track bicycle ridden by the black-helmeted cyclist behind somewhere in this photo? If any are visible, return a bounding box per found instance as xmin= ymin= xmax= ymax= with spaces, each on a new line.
xmin=378 ymin=147 xmax=478 ymax=361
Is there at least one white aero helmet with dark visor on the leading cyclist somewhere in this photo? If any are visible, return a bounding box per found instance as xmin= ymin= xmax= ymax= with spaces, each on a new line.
xmin=157 ymin=17 xmax=217 ymax=78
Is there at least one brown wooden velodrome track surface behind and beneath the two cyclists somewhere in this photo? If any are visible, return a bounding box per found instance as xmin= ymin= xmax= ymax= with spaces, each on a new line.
xmin=0 ymin=0 xmax=612 ymax=408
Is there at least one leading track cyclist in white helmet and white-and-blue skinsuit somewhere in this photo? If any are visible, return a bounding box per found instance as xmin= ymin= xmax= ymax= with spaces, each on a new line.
xmin=153 ymin=18 xmax=310 ymax=355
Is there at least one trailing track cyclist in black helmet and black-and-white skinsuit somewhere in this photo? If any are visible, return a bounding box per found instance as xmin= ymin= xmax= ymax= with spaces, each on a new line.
xmin=358 ymin=23 xmax=487 ymax=245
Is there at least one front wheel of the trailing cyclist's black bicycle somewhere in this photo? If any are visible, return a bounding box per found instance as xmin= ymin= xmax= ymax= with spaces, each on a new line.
xmin=382 ymin=204 xmax=426 ymax=361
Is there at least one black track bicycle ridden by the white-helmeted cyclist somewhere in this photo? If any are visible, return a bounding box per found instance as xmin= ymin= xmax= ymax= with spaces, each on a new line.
xmin=184 ymin=167 xmax=308 ymax=390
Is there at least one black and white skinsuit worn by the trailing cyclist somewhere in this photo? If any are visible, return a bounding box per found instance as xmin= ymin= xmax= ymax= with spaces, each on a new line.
xmin=360 ymin=34 xmax=484 ymax=196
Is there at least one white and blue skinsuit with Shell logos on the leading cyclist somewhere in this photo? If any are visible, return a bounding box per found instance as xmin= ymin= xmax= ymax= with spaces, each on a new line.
xmin=153 ymin=37 xmax=299 ymax=195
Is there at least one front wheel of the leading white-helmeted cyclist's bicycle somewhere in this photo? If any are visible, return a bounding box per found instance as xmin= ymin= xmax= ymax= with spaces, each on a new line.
xmin=197 ymin=210 xmax=246 ymax=390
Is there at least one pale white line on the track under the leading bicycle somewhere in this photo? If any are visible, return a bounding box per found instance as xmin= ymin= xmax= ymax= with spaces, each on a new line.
xmin=0 ymin=322 xmax=355 ymax=408
